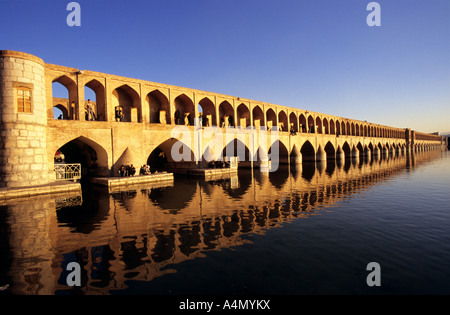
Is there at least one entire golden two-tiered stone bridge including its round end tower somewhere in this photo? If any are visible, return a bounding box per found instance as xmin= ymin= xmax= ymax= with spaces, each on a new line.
xmin=0 ymin=50 xmax=445 ymax=187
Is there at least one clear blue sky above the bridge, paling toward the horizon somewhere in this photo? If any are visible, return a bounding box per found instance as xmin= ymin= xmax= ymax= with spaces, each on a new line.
xmin=0 ymin=0 xmax=450 ymax=133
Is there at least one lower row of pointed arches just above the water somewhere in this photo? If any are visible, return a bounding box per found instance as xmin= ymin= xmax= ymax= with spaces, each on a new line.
xmin=57 ymin=131 xmax=418 ymax=177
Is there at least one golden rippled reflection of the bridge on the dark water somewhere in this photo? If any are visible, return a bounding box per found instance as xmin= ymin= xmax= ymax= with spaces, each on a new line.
xmin=3 ymin=152 xmax=440 ymax=294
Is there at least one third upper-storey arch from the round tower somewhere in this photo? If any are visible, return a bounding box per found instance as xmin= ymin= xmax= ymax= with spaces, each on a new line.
xmin=112 ymin=84 xmax=141 ymax=122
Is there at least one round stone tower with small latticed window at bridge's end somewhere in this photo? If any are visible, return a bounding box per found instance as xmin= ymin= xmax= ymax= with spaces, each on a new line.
xmin=0 ymin=50 xmax=49 ymax=187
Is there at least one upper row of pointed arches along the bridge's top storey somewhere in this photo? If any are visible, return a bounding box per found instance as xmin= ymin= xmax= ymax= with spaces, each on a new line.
xmin=52 ymin=75 xmax=405 ymax=139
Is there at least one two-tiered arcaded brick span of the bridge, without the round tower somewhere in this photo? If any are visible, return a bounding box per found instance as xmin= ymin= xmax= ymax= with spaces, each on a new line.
xmin=45 ymin=64 xmax=443 ymax=176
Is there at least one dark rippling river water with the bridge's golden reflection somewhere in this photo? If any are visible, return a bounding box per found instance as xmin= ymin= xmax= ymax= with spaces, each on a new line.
xmin=0 ymin=150 xmax=450 ymax=295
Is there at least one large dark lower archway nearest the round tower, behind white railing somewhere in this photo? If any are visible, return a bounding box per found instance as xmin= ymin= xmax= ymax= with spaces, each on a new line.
xmin=57 ymin=136 xmax=108 ymax=176
